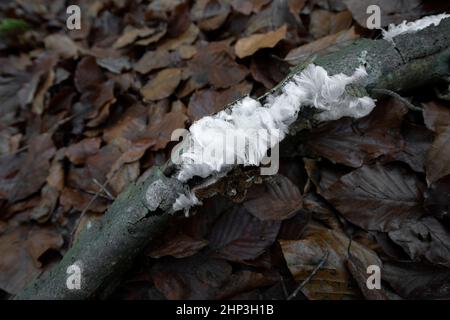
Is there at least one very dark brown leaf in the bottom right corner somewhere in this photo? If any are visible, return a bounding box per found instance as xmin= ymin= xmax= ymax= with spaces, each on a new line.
xmin=381 ymin=261 xmax=450 ymax=300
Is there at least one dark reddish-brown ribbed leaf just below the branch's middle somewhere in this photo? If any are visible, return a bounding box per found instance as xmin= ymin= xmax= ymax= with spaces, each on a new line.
xmin=208 ymin=205 xmax=280 ymax=262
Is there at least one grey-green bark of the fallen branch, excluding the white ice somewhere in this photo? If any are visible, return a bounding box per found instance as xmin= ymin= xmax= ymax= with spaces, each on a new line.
xmin=15 ymin=19 xmax=450 ymax=299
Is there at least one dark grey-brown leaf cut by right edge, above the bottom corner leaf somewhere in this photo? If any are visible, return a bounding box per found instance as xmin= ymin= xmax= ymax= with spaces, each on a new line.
xmin=389 ymin=217 xmax=450 ymax=268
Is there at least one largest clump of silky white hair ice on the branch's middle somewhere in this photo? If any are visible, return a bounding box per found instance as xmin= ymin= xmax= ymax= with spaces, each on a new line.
xmin=177 ymin=64 xmax=375 ymax=182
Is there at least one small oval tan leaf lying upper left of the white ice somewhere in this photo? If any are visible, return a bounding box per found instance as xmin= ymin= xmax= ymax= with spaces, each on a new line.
xmin=141 ymin=68 xmax=181 ymax=101
